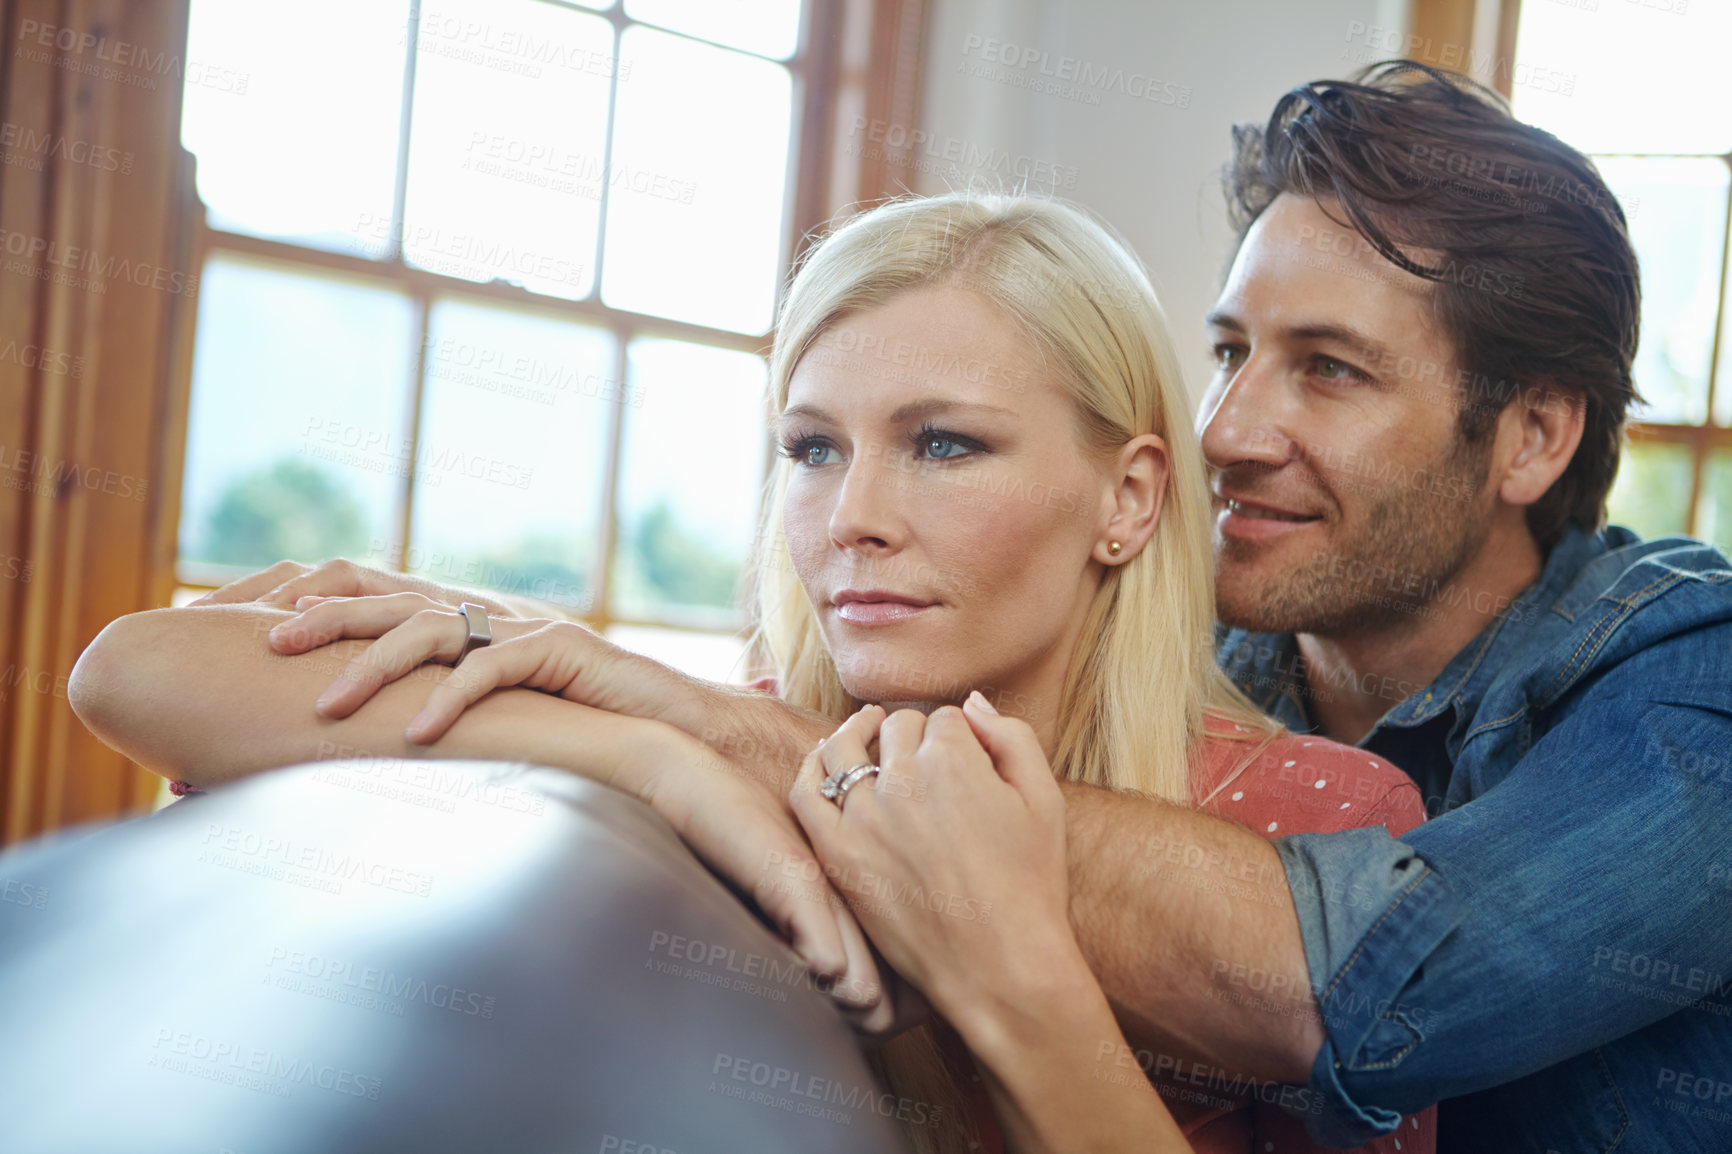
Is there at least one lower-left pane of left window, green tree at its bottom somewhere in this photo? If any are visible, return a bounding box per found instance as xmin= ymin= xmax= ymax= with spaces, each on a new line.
xmin=180 ymin=255 xmax=416 ymax=568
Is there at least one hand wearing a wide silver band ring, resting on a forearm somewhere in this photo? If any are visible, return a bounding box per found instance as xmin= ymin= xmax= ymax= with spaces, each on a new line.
xmin=259 ymin=593 xmax=688 ymax=745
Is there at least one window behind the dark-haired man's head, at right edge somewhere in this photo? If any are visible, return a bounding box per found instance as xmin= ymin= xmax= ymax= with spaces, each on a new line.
xmin=1514 ymin=0 xmax=1732 ymax=549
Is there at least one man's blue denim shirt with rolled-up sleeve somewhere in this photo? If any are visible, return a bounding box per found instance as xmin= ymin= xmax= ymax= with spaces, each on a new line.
xmin=1216 ymin=525 xmax=1732 ymax=1154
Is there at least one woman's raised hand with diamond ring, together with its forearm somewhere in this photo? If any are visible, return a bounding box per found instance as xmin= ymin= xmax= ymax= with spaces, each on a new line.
xmin=793 ymin=693 xmax=1190 ymax=1154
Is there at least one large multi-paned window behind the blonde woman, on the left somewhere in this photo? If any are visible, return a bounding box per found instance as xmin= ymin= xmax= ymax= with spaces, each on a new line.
xmin=177 ymin=0 xmax=818 ymax=677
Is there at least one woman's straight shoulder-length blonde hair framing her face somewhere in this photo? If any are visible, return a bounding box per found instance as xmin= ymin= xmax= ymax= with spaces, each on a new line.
xmin=752 ymin=192 xmax=1280 ymax=1152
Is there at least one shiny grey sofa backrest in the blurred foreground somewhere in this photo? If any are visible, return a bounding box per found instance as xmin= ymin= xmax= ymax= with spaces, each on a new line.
xmin=0 ymin=761 xmax=906 ymax=1154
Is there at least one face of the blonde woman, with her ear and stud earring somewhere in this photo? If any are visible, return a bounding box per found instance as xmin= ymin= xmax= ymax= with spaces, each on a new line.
xmin=778 ymin=286 xmax=1164 ymax=729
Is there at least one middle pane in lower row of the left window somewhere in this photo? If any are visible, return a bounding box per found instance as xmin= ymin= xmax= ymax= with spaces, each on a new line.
xmin=403 ymin=300 xmax=622 ymax=610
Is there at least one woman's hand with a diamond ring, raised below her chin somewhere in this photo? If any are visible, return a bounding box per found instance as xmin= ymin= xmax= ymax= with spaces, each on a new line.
xmin=792 ymin=697 xmax=1081 ymax=1022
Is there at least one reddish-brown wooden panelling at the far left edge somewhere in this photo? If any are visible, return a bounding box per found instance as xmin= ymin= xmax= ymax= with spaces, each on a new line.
xmin=0 ymin=0 xmax=197 ymax=842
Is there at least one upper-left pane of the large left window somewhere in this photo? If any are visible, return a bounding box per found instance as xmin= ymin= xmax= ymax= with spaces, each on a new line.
xmin=180 ymin=0 xmax=409 ymax=256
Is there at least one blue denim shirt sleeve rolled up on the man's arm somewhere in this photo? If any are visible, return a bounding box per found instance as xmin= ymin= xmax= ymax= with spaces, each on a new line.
xmin=1275 ymin=631 xmax=1732 ymax=1147
